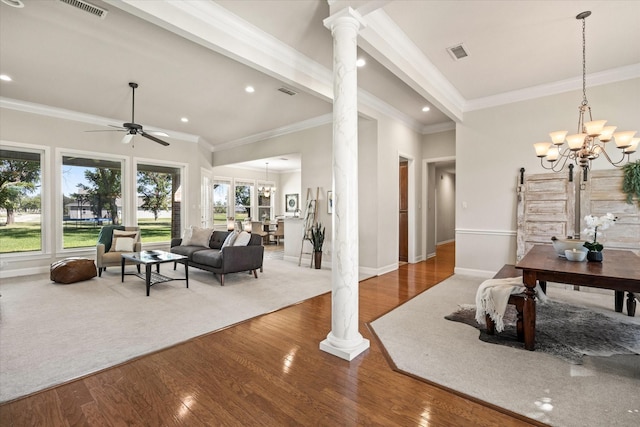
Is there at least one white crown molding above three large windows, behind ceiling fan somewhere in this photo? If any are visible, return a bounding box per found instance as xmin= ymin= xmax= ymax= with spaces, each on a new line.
xmin=0 ymin=97 xmax=200 ymax=145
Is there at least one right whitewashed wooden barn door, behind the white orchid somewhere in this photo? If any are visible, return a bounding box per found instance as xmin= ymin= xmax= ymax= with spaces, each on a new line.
xmin=580 ymin=169 xmax=640 ymax=252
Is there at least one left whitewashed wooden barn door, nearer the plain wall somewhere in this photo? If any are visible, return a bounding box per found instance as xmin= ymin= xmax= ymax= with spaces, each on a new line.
xmin=516 ymin=173 xmax=576 ymax=261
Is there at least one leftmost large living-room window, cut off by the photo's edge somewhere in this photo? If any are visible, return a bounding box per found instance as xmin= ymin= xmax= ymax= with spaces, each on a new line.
xmin=0 ymin=148 xmax=42 ymax=253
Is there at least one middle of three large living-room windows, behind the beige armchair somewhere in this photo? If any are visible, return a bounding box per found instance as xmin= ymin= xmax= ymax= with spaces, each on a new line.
xmin=62 ymin=156 xmax=123 ymax=249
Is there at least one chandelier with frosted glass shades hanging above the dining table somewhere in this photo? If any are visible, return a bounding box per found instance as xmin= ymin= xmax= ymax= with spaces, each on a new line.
xmin=533 ymin=11 xmax=640 ymax=181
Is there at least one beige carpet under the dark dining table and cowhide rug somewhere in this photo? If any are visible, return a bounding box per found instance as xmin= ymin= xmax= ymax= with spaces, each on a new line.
xmin=371 ymin=275 xmax=640 ymax=427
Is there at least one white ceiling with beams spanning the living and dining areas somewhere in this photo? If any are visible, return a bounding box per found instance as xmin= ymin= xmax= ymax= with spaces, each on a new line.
xmin=0 ymin=0 xmax=640 ymax=174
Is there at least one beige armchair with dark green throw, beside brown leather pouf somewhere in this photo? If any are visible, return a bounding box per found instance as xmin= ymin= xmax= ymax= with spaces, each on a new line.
xmin=96 ymin=225 xmax=142 ymax=277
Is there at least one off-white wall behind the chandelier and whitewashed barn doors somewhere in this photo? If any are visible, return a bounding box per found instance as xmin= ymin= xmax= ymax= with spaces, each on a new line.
xmin=456 ymin=79 xmax=640 ymax=275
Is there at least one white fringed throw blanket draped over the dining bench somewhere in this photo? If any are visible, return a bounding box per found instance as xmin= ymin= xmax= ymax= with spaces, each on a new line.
xmin=476 ymin=277 xmax=547 ymax=332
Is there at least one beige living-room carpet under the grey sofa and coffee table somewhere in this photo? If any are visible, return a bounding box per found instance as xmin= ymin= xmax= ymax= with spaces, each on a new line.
xmin=0 ymin=259 xmax=331 ymax=402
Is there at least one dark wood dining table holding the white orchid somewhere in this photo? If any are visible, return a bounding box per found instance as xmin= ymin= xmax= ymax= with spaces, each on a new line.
xmin=516 ymin=245 xmax=640 ymax=350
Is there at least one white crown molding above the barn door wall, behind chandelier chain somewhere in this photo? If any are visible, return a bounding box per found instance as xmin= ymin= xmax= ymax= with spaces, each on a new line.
xmin=464 ymin=64 xmax=640 ymax=112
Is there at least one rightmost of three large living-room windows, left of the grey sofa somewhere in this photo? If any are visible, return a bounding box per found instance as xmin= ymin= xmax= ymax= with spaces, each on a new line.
xmin=136 ymin=163 xmax=181 ymax=243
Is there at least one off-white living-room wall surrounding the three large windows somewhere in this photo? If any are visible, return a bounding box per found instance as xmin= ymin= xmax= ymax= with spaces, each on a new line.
xmin=0 ymin=109 xmax=211 ymax=277
